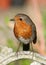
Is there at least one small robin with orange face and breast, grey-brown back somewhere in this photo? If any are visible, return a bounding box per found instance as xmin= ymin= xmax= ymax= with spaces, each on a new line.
xmin=10 ymin=13 xmax=37 ymax=51
